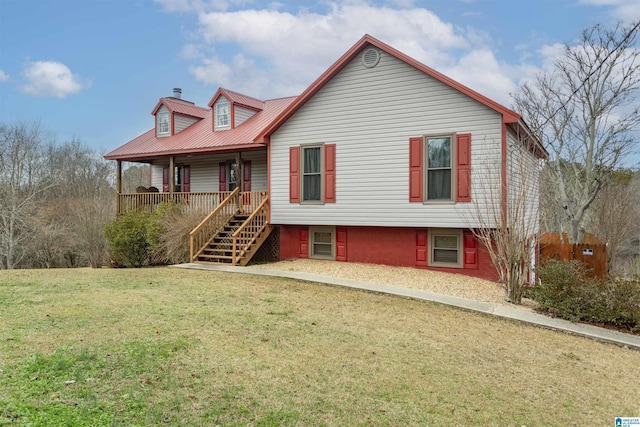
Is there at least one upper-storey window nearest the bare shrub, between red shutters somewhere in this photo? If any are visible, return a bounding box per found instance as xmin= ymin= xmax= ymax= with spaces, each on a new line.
xmin=425 ymin=136 xmax=453 ymax=201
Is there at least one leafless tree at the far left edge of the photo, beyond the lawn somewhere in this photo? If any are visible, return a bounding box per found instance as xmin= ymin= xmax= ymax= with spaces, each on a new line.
xmin=0 ymin=123 xmax=53 ymax=269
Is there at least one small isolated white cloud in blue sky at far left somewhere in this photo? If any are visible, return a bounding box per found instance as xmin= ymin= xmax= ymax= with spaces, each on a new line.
xmin=22 ymin=61 xmax=88 ymax=98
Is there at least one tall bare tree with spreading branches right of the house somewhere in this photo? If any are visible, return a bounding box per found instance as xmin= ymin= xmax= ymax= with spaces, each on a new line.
xmin=513 ymin=21 xmax=640 ymax=243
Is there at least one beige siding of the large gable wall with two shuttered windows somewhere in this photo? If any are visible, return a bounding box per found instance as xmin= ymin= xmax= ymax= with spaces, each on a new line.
xmin=271 ymin=48 xmax=502 ymax=228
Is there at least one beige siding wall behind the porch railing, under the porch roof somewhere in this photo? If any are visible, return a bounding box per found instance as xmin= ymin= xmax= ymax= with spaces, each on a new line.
xmin=151 ymin=150 xmax=267 ymax=193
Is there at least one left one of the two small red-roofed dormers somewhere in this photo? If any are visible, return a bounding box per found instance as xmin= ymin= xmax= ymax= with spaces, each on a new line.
xmin=151 ymin=88 xmax=209 ymax=138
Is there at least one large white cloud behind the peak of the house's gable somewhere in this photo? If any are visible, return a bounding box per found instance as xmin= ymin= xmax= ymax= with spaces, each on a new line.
xmin=185 ymin=2 xmax=478 ymax=97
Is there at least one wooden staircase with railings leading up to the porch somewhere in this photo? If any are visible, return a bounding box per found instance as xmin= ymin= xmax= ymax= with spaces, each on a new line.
xmin=189 ymin=190 xmax=273 ymax=266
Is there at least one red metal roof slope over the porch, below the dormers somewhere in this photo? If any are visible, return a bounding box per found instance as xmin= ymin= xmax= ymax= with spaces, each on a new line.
xmin=104 ymin=97 xmax=296 ymax=161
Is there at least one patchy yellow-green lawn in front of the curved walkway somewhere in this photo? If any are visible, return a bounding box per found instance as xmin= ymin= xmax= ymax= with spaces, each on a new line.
xmin=0 ymin=268 xmax=640 ymax=426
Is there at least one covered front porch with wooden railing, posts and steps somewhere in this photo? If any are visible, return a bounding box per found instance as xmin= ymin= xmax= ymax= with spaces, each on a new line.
xmin=116 ymin=149 xmax=272 ymax=265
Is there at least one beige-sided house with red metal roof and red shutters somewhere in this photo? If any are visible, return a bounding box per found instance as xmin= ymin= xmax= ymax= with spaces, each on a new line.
xmin=105 ymin=35 xmax=546 ymax=278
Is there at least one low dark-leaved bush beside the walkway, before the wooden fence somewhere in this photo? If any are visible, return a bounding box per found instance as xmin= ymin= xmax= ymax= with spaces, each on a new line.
xmin=532 ymin=260 xmax=640 ymax=331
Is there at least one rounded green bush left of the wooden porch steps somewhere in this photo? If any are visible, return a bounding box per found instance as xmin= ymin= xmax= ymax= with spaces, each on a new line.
xmin=104 ymin=211 xmax=158 ymax=267
